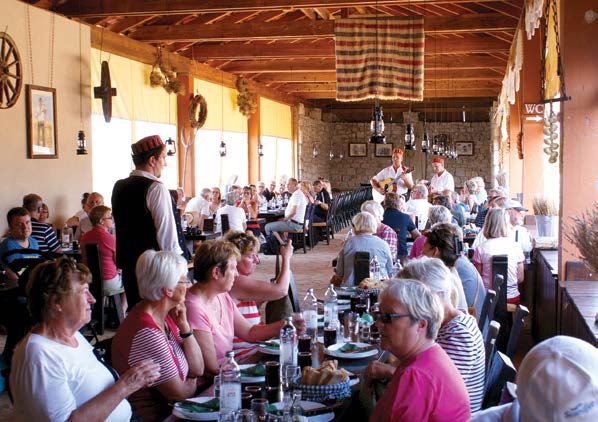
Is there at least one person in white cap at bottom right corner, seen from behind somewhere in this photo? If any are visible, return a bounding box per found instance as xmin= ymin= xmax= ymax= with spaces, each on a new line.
xmin=471 ymin=336 xmax=598 ymax=422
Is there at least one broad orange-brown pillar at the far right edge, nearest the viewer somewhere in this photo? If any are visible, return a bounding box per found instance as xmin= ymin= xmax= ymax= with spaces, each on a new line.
xmin=559 ymin=0 xmax=598 ymax=273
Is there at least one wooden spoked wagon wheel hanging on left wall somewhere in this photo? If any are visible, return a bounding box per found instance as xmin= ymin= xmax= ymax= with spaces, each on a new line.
xmin=0 ymin=32 xmax=23 ymax=108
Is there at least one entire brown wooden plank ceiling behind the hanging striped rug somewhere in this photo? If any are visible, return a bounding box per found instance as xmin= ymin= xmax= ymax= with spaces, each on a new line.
xmin=27 ymin=0 xmax=524 ymax=121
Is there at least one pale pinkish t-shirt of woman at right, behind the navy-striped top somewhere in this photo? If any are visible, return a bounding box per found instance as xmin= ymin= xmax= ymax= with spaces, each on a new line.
xmin=473 ymin=237 xmax=525 ymax=299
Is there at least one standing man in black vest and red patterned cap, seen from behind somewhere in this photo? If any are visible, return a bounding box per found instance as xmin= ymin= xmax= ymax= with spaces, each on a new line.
xmin=112 ymin=135 xmax=183 ymax=309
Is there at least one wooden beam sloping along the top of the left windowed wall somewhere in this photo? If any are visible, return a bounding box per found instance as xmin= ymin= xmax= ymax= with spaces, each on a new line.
xmin=90 ymin=27 xmax=301 ymax=105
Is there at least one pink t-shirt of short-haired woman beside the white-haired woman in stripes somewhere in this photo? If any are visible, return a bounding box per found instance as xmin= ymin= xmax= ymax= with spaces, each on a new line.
xmin=185 ymin=293 xmax=239 ymax=365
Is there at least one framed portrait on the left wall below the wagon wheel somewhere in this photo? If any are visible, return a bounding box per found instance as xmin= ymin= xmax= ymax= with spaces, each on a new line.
xmin=26 ymin=85 xmax=58 ymax=158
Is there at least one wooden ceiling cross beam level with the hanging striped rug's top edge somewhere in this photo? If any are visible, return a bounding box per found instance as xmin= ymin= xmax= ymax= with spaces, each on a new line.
xmin=131 ymin=13 xmax=517 ymax=42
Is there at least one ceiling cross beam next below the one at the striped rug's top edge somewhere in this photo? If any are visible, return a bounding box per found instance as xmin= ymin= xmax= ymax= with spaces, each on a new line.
xmin=184 ymin=38 xmax=510 ymax=61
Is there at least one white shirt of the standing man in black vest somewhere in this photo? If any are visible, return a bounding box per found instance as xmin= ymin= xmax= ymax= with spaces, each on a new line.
xmin=131 ymin=170 xmax=183 ymax=255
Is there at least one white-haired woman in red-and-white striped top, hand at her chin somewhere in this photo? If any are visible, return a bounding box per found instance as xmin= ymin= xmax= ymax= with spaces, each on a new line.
xmin=112 ymin=250 xmax=204 ymax=421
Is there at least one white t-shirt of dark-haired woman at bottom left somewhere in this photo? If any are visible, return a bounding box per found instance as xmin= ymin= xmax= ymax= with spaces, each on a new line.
xmin=10 ymin=332 xmax=131 ymax=422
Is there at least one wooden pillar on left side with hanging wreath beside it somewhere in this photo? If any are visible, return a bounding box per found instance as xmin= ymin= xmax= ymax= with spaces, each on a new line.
xmin=177 ymin=73 xmax=196 ymax=196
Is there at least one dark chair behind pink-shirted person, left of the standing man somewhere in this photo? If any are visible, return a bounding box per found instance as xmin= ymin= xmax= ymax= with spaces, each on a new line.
xmin=85 ymin=244 xmax=125 ymax=335
